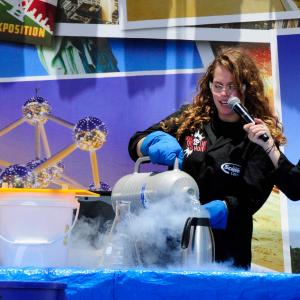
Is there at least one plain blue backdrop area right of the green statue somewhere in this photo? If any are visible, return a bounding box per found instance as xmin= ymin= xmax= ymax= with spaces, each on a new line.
xmin=110 ymin=39 xmax=203 ymax=72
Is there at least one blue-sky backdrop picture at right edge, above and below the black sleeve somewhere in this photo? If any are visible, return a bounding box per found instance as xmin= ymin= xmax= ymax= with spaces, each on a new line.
xmin=277 ymin=35 xmax=300 ymax=251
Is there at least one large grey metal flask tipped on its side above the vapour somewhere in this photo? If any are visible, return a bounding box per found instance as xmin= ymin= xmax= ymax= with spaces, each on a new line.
xmin=111 ymin=157 xmax=199 ymax=212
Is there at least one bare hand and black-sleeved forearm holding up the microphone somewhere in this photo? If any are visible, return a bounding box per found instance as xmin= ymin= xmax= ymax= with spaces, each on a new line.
xmin=244 ymin=119 xmax=300 ymax=201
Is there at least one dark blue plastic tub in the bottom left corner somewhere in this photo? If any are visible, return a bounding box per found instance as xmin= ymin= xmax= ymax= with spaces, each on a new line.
xmin=0 ymin=281 xmax=67 ymax=300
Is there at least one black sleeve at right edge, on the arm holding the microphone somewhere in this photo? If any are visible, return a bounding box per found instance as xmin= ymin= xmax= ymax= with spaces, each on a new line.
xmin=273 ymin=153 xmax=300 ymax=201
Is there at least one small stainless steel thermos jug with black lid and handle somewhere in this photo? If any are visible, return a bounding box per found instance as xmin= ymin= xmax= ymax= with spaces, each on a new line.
xmin=181 ymin=217 xmax=215 ymax=267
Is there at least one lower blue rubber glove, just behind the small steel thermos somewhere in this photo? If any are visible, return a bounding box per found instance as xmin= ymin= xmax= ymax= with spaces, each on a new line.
xmin=203 ymin=200 xmax=228 ymax=229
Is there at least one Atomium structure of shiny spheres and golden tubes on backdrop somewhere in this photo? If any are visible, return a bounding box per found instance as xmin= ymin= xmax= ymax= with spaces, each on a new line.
xmin=0 ymin=96 xmax=107 ymax=191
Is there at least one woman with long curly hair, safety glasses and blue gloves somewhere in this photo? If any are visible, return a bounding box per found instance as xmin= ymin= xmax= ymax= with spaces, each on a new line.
xmin=129 ymin=49 xmax=285 ymax=269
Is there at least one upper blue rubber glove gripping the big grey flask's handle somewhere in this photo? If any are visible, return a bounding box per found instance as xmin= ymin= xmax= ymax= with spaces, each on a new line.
xmin=140 ymin=131 xmax=184 ymax=169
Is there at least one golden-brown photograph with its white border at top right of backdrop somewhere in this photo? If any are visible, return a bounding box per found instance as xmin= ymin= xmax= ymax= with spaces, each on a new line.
xmin=119 ymin=0 xmax=300 ymax=29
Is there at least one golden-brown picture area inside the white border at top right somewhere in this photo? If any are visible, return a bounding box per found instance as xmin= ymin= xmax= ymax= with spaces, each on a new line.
xmin=126 ymin=0 xmax=285 ymax=21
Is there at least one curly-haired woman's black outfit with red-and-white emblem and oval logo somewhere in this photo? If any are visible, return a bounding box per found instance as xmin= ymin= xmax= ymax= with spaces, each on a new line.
xmin=129 ymin=107 xmax=274 ymax=268
